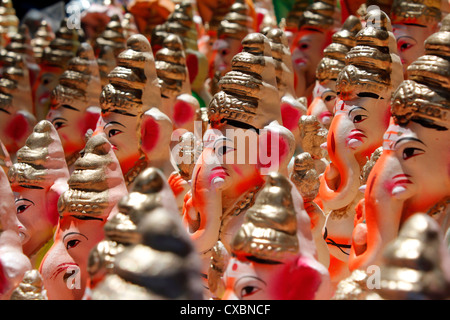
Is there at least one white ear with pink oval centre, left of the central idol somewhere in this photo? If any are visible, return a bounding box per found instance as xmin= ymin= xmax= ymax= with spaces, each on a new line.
xmin=140 ymin=107 xmax=173 ymax=159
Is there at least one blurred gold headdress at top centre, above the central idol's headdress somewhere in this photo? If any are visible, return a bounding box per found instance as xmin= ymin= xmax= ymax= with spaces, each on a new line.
xmin=217 ymin=0 xmax=254 ymax=41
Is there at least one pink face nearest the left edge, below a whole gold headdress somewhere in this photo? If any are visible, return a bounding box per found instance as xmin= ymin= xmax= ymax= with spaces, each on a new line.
xmin=13 ymin=186 xmax=58 ymax=257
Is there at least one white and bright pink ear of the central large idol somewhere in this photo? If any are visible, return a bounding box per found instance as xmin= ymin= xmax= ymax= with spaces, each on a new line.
xmin=258 ymin=120 xmax=295 ymax=175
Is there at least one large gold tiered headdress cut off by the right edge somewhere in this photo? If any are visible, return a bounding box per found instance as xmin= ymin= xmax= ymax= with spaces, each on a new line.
xmin=391 ymin=16 xmax=450 ymax=129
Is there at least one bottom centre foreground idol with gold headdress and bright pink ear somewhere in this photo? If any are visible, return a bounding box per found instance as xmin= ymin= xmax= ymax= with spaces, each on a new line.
xmin=217 ymin=172 xmax=331 ymax=300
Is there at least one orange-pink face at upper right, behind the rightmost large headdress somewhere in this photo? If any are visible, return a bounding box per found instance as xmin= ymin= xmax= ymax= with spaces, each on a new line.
xmin=393 ymin=24 xmax=434 ymax=77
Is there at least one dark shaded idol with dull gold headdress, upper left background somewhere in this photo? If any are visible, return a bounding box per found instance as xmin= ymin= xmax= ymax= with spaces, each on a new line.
xmin=32 ymin=18 xmax=80 ymax=120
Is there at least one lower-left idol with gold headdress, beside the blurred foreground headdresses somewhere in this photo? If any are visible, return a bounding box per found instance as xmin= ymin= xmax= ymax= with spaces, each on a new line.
xmin=39 ymin=134 xmax=128 ymax=300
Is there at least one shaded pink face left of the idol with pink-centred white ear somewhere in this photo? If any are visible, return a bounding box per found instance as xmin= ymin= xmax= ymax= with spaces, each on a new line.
xmin=47 ymin=105 xmax=99 ymax=156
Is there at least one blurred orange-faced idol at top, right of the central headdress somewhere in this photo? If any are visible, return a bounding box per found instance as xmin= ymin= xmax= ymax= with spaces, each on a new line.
xmin=291 ymin=0 xmax=336 ymax=104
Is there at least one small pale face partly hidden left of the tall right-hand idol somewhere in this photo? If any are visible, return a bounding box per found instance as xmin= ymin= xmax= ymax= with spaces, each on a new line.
xmin=308 ymin=80 xmax=338 ymax=128
